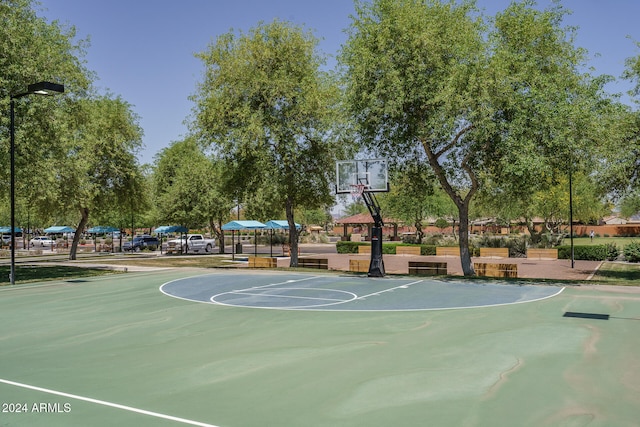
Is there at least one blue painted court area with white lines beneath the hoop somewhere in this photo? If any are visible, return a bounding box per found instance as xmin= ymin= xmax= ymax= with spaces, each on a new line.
xmin=160 ymin=273 xmax=564 ymax=311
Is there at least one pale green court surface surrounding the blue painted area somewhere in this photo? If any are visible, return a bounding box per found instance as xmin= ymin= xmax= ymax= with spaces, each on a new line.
xmin=0 ymin=270 xmax=640 ymax=427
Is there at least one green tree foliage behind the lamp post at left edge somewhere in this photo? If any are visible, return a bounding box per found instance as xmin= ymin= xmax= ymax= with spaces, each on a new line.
xmin=0 ymin=0 xmax=93 ymax=232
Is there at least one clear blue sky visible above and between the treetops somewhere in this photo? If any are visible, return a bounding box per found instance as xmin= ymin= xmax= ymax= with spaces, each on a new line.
xmin=39 ymin=0 xmax=640 ymax=163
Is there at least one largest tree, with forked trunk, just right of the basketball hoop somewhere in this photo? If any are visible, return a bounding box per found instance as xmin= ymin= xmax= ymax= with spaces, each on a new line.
xmin=340 ymin=0 xmax=597 ymax=275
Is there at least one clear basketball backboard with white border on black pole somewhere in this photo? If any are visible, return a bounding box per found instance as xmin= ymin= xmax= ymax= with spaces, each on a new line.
xmin=336 ymin=159 xmax=389 ymax=194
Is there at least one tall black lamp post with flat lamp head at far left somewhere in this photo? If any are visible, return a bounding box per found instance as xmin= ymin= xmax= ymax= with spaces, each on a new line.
xmin=9 ymin=82 xmax=64 ymax=285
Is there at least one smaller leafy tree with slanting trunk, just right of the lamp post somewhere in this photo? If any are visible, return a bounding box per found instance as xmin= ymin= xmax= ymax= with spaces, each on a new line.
xmin=51 ymin=96 xmax=142 ymax=259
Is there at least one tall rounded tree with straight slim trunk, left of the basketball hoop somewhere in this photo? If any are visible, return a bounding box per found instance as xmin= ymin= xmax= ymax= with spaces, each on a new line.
xmin=192 ymin=20 xmax=340 ymax=266
